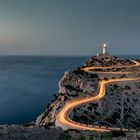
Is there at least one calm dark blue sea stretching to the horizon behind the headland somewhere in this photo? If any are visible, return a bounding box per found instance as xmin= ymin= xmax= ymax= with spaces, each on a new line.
xmin=0 ymin=55 xmax=140 ymax=124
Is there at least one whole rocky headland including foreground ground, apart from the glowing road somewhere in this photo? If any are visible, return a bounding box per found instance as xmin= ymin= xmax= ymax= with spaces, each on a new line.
xmin=0 ymin=54 xmax=140 ymax=140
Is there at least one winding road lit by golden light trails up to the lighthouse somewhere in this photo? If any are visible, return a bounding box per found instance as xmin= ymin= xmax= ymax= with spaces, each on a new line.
xmin=55 ymin=60 xmax=140 ymax=132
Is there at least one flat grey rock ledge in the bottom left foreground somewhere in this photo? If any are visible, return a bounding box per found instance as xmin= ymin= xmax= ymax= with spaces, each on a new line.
xmin=0 ymin=125 xmax=62 ymax=140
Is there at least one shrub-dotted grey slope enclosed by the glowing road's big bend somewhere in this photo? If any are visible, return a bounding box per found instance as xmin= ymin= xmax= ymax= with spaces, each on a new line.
xmin=72 ymin=81 xmax=140 ymax=129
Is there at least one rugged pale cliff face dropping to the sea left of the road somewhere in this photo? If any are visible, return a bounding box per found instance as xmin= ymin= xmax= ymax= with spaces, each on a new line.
xmin=35 ymin=69 xmax=98 ymax=126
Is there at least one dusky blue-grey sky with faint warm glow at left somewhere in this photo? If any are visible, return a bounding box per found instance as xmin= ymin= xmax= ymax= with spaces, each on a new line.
xmin=0 ymin=0 xmax=140 ymax=56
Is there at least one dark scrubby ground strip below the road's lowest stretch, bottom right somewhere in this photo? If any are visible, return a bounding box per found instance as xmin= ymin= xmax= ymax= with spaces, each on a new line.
xmin=58 ymin=130 xmax=140 ymax=140
